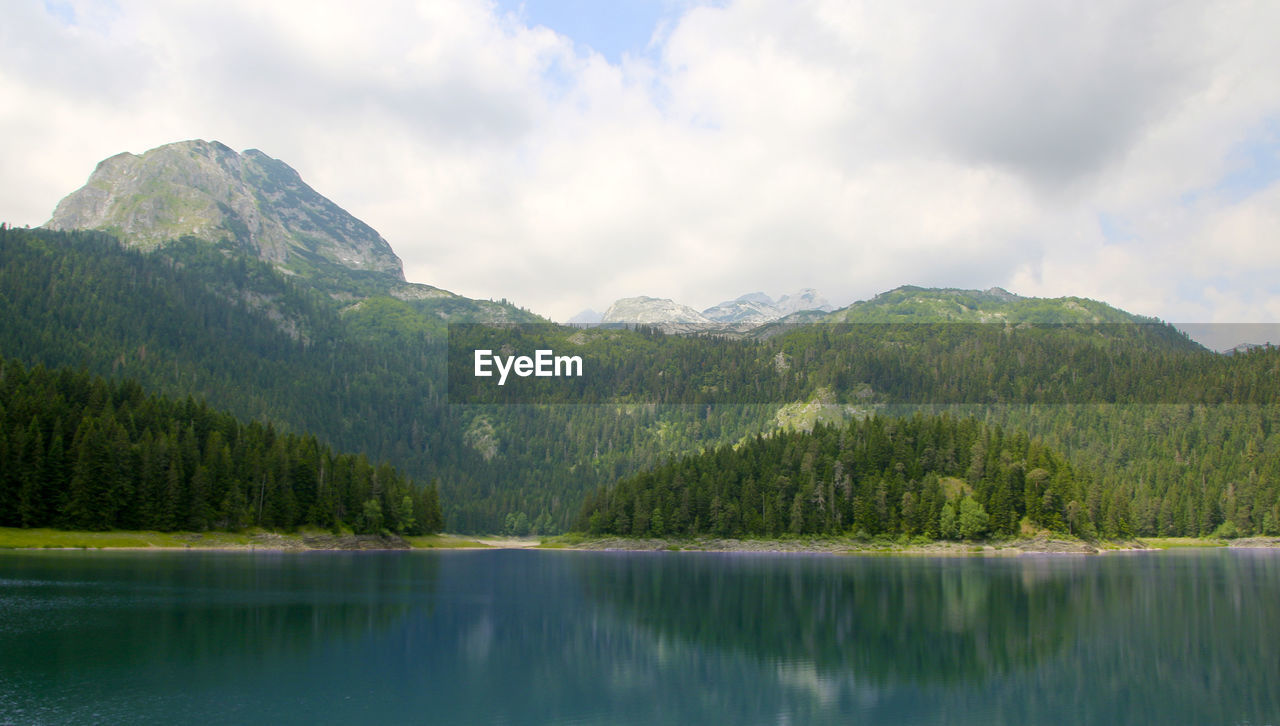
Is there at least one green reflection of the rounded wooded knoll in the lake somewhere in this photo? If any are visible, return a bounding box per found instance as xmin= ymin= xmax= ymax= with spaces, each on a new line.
xmin=581 ymin=556 xmax=1082 ymax=684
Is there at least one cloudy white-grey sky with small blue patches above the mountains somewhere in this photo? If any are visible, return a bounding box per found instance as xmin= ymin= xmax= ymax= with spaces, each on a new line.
xmin=0 ymin=0 xmax=1280 ymax=321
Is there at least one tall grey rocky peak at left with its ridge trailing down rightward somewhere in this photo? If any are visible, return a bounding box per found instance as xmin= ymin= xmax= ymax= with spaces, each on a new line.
xmin=45 ymin=140 xmax=545 ymax=333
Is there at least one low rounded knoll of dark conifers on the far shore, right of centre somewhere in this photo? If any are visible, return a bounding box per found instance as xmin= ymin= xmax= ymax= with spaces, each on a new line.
xmin=577 ymin=416 xmax=1093 ymax=539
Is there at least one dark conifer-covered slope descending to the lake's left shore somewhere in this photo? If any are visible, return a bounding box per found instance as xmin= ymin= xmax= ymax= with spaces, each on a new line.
xmin=0 ymin=360 xmax=442 ymax=534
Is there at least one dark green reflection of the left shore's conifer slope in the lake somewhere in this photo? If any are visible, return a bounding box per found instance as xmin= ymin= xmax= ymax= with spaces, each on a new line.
xmin=0 ymin=552 xmax=438 ymax=675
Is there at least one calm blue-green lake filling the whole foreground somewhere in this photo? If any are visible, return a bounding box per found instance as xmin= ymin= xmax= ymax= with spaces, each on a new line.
xmin=0 ymin=549 xmax=1280 ymax=725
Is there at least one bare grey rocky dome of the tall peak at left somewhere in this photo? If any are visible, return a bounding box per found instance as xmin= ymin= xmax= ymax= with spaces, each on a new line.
xmin=45 ymin=140 xmax=404 ymax=280
